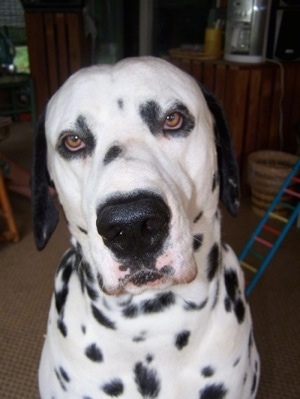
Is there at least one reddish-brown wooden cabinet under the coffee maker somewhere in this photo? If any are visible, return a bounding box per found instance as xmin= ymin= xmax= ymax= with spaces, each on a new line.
xmin=170 ymin=55 xmax=300 ymax=193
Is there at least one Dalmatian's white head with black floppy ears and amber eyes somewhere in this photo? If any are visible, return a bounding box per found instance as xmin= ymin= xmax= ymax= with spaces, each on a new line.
xmin=32 ymin=57 xmax=239 ymax=294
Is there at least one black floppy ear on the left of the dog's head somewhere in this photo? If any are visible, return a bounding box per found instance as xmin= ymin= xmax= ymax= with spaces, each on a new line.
xmin=31 ymin=113 xmax=58 ymax=250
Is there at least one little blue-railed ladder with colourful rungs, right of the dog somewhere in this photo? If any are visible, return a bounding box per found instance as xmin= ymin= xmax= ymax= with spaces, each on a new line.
xmin=238 ymin=159 xmax=300 ymax=295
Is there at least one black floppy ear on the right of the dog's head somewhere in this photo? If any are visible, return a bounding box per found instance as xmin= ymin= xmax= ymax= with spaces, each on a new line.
xmin=201 ymin=86 xmax=240 ymax=216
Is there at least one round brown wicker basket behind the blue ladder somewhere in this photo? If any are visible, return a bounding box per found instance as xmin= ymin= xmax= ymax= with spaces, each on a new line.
xmin=248 ymin=151 xmax=298 ymax=216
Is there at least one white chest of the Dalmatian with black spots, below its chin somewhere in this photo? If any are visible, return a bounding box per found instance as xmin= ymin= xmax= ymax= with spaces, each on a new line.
xmin=40 ymin=251 xmax=254 ymax=399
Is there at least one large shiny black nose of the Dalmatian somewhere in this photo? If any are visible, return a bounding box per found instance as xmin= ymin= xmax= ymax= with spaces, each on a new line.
xmin=96 ymin=193 xmax=170 ymax=259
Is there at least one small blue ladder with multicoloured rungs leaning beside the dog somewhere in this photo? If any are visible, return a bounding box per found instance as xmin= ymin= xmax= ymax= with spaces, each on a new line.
xmin=238 ymin=159 xmax=300 ymax=295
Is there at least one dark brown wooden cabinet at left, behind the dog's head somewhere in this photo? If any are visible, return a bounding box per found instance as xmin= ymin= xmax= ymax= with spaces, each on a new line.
xmin=25 ymin=11 xmax=91 ymax=113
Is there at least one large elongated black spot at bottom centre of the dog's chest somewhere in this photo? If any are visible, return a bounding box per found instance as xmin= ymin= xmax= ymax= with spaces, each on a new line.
xmin=134 ymin=362 xmax=160 ymax=399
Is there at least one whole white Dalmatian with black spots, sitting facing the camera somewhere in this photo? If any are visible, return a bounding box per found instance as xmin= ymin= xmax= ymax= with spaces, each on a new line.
xmin=32 ymin=57 xmax=260 ymax=399
